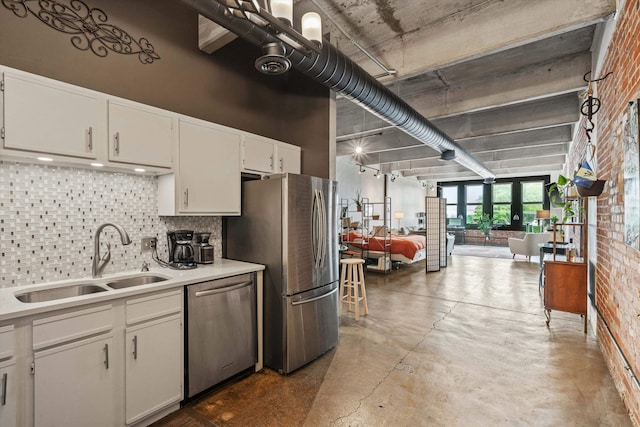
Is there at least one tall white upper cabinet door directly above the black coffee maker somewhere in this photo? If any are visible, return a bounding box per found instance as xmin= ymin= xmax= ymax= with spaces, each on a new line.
xmin=178 ymin=120 xmax=241 ymax=215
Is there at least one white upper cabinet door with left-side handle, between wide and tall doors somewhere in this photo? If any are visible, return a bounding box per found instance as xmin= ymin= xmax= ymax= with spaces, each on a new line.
xmin=109 ymin=100 xmax=173 ymax=168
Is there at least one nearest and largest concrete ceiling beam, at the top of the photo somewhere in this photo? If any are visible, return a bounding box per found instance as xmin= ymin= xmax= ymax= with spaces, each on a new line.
xmin=344 ymin=0 xmax=616 ymax=78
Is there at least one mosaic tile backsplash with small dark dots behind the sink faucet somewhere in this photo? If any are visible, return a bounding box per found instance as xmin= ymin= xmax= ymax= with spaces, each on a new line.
xmin=0 ymin=161 xmax=222 ymax=288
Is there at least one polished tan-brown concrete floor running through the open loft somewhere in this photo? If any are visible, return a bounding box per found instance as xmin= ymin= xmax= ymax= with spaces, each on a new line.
xmin=157 ymin=255 xmax=631 ymax=426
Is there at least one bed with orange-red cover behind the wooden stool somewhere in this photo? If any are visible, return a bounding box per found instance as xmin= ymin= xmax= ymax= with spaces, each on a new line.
xmin=344 ymin=231 xmax=426 ymax=264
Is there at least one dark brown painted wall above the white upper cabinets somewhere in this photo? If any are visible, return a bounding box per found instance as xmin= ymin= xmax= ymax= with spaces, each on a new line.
xmin=0 ymin=0 xmax=330 ymax=177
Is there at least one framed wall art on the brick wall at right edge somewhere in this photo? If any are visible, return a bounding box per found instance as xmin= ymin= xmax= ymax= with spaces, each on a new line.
xmin=622 ymin=100 xmax=640 ymax=250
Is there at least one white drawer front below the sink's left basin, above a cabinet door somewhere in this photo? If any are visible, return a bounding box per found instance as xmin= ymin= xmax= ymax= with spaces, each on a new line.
xmin=33 ymin=304 xmax=113 ymax=350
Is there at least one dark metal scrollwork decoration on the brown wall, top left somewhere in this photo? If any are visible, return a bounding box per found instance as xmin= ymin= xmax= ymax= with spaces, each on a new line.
xmin=2 ymin=0 xmax=160 ymax=64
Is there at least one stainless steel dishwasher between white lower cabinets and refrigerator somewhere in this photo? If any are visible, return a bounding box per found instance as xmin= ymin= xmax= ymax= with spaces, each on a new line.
xmin=185 ymin=273 xmax=258 ymax=397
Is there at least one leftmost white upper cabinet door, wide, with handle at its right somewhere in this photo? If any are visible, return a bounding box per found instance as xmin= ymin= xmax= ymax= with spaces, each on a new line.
xmin=4 ymin=72 xmax=100 ymax=159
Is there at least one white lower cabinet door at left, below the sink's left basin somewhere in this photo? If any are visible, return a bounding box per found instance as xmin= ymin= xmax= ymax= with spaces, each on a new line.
xmin=34 ymin=335 xmax=115 ymax=427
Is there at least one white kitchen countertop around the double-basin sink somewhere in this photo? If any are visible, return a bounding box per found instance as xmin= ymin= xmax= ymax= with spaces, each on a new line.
xmin=0 ymin=259 xmax=264 ymax=322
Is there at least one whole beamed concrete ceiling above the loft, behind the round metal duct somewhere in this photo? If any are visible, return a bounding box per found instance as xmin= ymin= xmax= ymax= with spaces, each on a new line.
xmin=295 ymin=0 xmax=616 ymax=181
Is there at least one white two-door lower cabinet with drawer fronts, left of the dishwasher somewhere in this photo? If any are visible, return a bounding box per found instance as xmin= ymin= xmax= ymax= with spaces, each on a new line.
xmin=26 ymin=289 xmax=184 ymax=427
